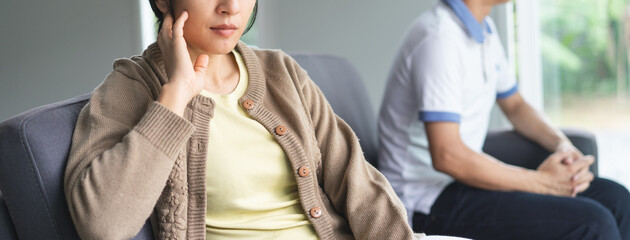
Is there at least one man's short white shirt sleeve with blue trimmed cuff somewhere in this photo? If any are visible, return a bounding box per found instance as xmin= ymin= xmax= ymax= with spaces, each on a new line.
xmin=406 ymin=37 xmax=463 ymax=123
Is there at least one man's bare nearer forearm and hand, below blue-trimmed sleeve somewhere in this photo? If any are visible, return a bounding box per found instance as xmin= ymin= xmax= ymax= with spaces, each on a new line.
xmin=425 ymin=122 xmax=594 ymax=196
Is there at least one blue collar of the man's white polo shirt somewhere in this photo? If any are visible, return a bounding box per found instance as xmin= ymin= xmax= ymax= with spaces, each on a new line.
xmin=443 ymin=0 xmax=492 ymax=43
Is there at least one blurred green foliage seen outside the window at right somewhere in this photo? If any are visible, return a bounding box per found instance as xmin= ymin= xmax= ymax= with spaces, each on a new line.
xmin=540 ymin=0 xmax=630 ymax=97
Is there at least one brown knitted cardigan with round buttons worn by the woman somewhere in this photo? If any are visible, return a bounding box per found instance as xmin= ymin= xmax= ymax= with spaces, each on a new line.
xmin=64 ymin=43 xmax=412 ymax=239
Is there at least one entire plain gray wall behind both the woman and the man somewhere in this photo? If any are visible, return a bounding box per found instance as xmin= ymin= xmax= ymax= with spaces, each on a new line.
xmin=0 ymin=0 xmax=505 ymax=125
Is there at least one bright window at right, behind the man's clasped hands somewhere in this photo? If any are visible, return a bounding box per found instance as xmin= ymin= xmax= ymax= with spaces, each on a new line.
xmin=514 ymin=0 xmax=630 ymax=186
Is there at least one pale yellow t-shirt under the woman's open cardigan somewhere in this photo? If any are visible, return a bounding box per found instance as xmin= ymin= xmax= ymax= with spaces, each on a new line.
xmin=201 ymin=51 xmax=317 ymax=239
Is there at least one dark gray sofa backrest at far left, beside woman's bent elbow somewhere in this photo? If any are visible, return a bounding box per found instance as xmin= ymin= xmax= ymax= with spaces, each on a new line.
xmin=0 ymin=94 xmax=152 ymax=239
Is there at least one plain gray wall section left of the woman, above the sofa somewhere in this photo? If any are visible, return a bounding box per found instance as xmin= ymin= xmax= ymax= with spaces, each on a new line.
xmin=0 ymin=0 xmax=141 ymax=121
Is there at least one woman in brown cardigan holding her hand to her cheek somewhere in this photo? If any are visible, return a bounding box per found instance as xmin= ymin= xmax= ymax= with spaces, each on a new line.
xmin=65 ymin=0 xmax=422 ymax=239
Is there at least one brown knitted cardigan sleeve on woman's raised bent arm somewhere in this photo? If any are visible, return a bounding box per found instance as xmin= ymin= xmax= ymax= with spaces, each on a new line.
xmin=64 ymin=67 xmax=194 ymax=239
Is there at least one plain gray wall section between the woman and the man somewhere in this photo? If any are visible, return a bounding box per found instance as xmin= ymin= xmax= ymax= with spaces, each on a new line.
xmin=256 ymin=0 xmax=434 ymax=109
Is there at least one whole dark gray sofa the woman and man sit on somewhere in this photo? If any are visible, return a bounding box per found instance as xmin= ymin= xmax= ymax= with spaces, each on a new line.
xmin=0 ymin=54 xmax=597 ymax=239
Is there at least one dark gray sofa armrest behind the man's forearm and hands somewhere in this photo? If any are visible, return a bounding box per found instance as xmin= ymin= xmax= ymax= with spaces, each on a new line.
xmin=483 ymin=129 xmax=598 ymax=175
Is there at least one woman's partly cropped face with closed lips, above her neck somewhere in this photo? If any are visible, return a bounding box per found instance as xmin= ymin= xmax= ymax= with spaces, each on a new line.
xmin=163 ymin=0 xmax=256 ymax=54
